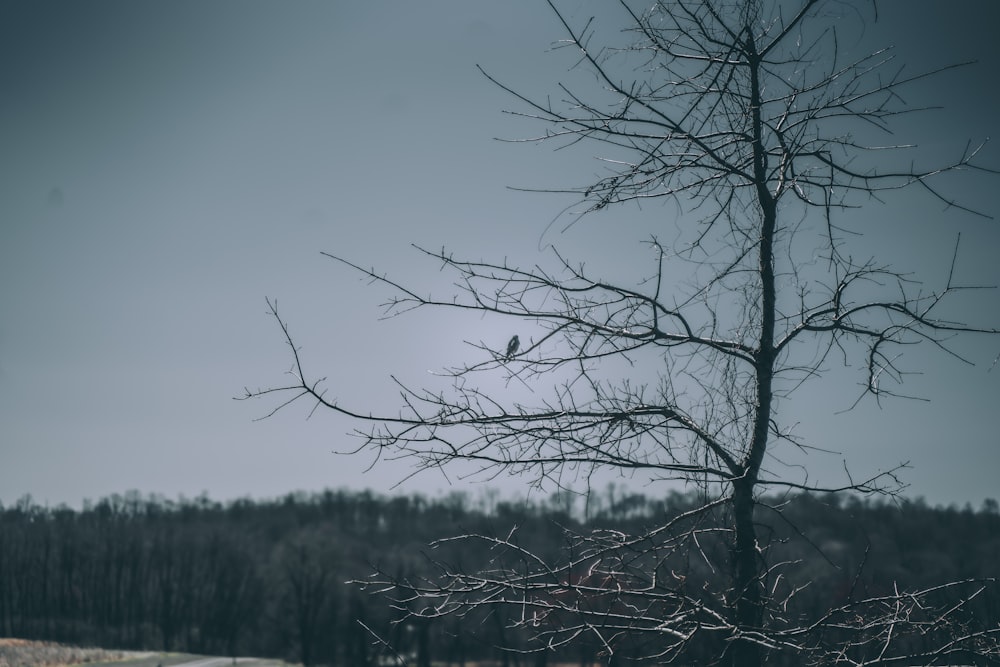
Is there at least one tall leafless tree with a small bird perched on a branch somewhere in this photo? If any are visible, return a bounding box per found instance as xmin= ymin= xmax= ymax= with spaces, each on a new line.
xmin=246 ymin=0 xmax=1000 ymax=667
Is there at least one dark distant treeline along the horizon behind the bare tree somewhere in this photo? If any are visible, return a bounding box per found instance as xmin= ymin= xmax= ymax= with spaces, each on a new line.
xmin=0 ymin=487 xmax=1000 ymax=666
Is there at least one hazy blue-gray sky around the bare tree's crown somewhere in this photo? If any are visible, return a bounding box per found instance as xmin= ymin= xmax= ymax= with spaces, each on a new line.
xmin=0 ymin=0 xmax=1000 ymax=505
